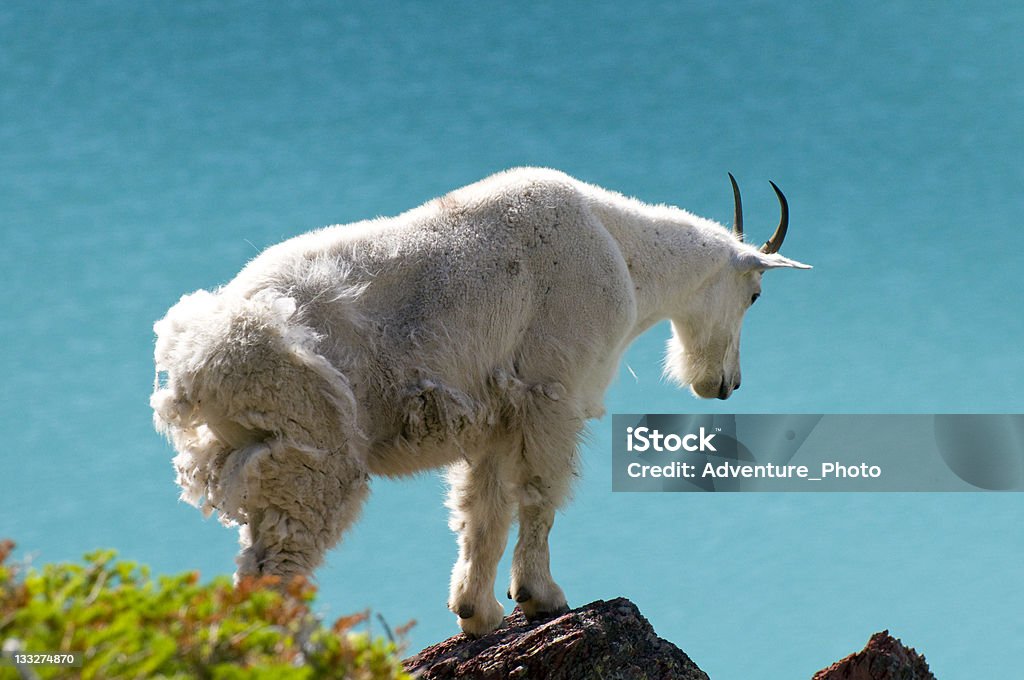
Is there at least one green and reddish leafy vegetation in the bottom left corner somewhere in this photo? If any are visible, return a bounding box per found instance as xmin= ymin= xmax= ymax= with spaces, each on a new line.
xmin=0 ymin=541 xmax=409 ymax=680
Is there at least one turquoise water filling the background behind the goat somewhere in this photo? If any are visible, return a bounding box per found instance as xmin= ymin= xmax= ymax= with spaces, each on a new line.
xmin=0 ymin=1 xmax=1024 ymax=680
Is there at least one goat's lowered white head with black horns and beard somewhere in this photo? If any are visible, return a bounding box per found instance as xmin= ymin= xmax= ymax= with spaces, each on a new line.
xmin=666 ymin=173 xmax=811 ymax=399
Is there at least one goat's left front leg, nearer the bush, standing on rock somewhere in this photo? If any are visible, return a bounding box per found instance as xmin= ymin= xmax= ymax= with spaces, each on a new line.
xmin=447 ymin=455 xmax=512 ymax=637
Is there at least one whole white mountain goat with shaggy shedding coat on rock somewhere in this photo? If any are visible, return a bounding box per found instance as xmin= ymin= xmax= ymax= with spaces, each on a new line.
xmin=151 ymin=168 xmax=808 ymax=636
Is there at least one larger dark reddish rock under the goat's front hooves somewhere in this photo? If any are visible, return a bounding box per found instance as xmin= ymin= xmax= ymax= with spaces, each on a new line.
xmin=403 ymin=598 xmax=708 ymax=680
